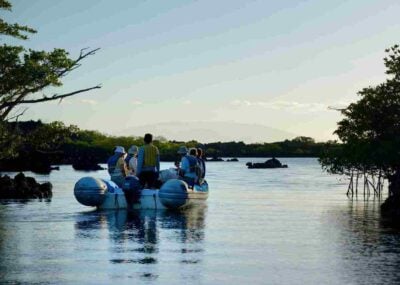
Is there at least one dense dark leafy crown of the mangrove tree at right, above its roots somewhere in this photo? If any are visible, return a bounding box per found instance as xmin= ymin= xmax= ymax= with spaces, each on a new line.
xmin=320 ymin=45 xmax=400 ymax=176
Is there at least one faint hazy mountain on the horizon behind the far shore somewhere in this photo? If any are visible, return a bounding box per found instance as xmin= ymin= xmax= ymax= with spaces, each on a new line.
xmin=116 ymin=122 xmax=297 ymax=143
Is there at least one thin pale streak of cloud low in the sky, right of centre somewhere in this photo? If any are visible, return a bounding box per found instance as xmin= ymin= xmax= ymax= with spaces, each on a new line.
xmin=231 ymin=100 xmax=328 ymax=112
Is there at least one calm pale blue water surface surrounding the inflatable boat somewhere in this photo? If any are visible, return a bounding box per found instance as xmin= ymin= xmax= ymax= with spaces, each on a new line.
xmin=0 ymin=159 xmax=400 ymax=284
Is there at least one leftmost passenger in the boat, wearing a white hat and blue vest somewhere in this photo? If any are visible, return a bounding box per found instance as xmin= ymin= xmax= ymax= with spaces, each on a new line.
xmin=107 ymin=146 xmax=128 ymax=187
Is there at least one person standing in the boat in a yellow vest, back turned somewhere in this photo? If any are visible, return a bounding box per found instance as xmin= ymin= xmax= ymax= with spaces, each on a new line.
xmin=137 ymin=134 xmax=160 ymax=188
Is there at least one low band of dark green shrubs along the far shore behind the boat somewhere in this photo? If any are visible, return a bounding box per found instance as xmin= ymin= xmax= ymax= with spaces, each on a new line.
xmin=0 ymin=120 xmax=328 ymax=173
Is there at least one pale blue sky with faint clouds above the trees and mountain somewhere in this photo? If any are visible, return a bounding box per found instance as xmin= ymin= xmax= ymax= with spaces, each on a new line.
xmin=1 ymin=0 xmax=400 ymax=141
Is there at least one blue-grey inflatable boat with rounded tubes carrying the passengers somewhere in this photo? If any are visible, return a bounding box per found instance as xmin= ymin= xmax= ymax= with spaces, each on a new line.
xmin=74 ymin=177 xmax=208 ymax=209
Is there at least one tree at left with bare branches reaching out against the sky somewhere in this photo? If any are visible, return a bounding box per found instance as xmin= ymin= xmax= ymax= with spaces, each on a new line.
xmin=0 ymin=0 xmax=101 ymax=158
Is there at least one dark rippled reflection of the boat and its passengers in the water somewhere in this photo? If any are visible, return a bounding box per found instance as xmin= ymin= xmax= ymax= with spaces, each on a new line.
xmin=75 ymin=207 xmax=206 ymax=280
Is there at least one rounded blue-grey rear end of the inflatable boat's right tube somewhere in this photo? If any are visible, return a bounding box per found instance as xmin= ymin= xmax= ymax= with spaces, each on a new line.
xmin=158 ymin=179 xmax=188 ymax=209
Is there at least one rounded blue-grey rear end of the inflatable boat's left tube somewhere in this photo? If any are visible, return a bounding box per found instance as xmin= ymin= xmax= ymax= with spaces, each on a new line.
xmin=74 ymin=177 xmax=107 ymax=207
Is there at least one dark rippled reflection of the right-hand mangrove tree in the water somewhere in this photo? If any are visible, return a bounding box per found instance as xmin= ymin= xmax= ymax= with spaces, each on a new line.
xmin=329 ymin=199 xmax=400 ymax=284
